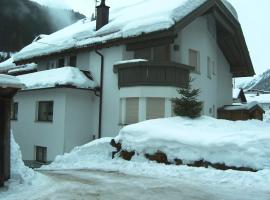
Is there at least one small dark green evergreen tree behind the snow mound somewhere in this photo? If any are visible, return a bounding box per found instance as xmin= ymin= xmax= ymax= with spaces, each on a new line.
xmin=172 ymin=78 xmax=203 ymax=118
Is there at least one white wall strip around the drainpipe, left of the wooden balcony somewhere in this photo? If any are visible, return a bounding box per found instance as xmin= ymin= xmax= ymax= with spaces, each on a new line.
xmin=90 ymin=46 xmax=125 ymax=137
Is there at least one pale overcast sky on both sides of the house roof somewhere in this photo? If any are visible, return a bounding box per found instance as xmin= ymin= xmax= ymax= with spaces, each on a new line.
xmin=30 ymin=0 xmax=270 ymax=77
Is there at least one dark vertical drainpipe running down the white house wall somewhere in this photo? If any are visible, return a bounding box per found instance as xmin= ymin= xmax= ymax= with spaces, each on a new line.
xmin=95 ymin=50 xmax=104 ymax=138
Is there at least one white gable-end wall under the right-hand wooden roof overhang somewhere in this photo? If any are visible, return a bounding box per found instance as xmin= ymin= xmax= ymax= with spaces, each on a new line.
xmin=171 ymin=16 xmax=232 ymax=116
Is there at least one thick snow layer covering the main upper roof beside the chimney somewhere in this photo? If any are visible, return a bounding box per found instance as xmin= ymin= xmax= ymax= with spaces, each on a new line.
xmin=14 ymin=0 xmax=236 ymax=61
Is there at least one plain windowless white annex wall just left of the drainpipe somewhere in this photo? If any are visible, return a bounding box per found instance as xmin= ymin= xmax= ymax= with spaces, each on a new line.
xmin=64 ymin=89 xmax=98 ymax=152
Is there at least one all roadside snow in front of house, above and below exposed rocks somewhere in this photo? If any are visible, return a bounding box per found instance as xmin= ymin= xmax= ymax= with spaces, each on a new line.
xmin=39 ymin=117 xmax=270 ymax=190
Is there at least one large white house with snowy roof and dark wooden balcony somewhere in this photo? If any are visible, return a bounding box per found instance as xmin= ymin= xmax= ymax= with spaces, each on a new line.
xmin=0 ymin=0 xmax=254 ymax=165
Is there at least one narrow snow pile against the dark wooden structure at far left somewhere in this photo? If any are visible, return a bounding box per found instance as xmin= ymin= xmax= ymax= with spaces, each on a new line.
xmin=10 ymin=134 xmax=36 ymax=183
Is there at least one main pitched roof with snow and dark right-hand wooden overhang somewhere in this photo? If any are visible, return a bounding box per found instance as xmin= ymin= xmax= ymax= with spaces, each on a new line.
xmin=14 ymin=0 xmax=254 ymax=77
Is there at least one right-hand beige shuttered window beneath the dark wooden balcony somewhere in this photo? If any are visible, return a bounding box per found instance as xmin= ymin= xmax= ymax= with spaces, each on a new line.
xmin=146 ymin=98 xmax=165 ymax=119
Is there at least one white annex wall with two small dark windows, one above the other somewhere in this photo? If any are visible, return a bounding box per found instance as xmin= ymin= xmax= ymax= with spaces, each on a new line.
xmin=11 ymin=90 xmax=66 ymax=161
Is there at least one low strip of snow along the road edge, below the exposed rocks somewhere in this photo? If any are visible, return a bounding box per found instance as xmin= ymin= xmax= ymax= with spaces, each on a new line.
xmin=41 ymin=133 xmax=270 ymax=190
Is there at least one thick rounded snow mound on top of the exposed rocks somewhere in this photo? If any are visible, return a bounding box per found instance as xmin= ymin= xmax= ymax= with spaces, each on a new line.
xmin=116 ymin=116 xmax=270 ymax=169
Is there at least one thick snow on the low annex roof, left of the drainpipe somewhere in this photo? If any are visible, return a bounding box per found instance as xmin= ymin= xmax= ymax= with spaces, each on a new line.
xmin=17 ymin=67 xmax=95 ymax=90
